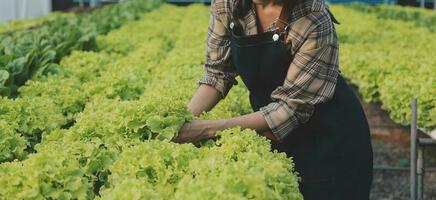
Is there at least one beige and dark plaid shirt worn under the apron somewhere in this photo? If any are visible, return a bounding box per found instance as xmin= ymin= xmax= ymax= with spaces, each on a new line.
xmin=199 ymin=0 xmax=339 ymax=140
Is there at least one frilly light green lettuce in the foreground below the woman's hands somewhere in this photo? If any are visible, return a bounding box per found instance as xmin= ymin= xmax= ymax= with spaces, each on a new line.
xmin=101 ymin=129 xmax=302 ymax=199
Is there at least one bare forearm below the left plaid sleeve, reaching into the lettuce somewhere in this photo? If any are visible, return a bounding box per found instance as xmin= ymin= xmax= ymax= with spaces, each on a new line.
xmin=188 ymin=84 xmax=222 ymax=116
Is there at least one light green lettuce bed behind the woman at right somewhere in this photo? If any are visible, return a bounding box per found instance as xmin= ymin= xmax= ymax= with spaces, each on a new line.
xmin=332 ymin=5 xmax=436 ymax=130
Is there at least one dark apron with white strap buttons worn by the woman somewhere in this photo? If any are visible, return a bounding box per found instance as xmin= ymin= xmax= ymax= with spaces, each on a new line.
xmin=230 ymin=7 xmax=372 ymax=200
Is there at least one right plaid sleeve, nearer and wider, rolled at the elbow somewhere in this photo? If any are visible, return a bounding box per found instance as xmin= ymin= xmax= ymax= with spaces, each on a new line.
xmin=260 ymin=12 xmax=339 ymax=140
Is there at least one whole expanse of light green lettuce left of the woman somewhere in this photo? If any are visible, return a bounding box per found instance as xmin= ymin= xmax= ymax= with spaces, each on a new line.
xmin=0 ymin=5 xmax=302 ymax=199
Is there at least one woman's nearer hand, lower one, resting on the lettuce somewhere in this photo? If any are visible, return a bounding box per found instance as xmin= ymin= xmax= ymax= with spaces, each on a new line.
xmin=173 ymin=120 xmax=223 ymax=143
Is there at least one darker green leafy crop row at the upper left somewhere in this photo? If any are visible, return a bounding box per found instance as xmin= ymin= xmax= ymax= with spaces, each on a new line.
xmin=0 ymin=0 xmax=160 ymax=97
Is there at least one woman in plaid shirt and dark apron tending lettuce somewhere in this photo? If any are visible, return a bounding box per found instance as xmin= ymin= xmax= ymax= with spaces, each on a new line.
xmin=175 ymin=0 xmax=372 ymax=200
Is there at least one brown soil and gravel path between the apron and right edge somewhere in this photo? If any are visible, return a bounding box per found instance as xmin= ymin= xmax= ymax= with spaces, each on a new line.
xmin=354 ymin=87 xmax=436 ymax=200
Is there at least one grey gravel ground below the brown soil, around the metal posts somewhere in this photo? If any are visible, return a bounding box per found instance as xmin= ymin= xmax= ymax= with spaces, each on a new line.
xmin=371 ymin=138 xmax=436 ymax=200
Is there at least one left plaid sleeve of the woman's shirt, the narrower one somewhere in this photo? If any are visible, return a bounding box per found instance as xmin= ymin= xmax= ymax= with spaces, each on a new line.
xmin=199 ymin=1 xmax=237 ymax=98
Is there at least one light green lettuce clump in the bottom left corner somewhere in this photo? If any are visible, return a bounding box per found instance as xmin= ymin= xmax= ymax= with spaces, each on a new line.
xmin=0 ymin=141 xmax=93 ymax=199
